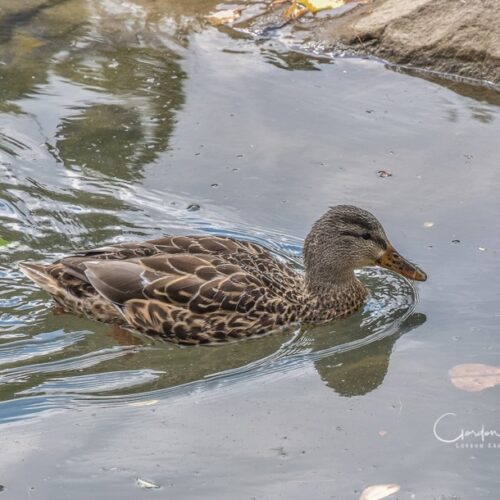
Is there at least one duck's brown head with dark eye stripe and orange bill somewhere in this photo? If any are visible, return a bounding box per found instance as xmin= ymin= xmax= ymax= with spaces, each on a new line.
xmin=304 ymin=205 xmax=427 ymax=289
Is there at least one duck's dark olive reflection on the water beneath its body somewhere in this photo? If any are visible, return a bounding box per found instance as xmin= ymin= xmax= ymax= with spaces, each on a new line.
xmin=104 ymin=304 xmax=426 ymax=397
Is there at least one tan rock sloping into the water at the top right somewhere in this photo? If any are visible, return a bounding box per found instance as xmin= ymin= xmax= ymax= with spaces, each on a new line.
xmin=311 ymin=0 xmax=500 ymax=84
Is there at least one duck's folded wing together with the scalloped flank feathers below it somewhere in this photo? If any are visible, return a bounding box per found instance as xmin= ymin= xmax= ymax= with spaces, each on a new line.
xmin=86 ymin=254 xmax=294 ymax=344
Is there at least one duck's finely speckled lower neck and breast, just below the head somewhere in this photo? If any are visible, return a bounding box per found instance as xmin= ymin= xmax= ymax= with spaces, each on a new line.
xmin=305 ymin=271 xmax=367 ymax=321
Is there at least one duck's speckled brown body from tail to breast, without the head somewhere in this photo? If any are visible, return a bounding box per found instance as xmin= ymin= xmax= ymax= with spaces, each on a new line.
xmin=20 ymin=236 xmax=366 ymax=344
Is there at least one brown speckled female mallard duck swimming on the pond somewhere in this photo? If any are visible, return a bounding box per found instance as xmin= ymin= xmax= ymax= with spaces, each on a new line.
xmin=21 ymin=205 xmax=427 ymax=344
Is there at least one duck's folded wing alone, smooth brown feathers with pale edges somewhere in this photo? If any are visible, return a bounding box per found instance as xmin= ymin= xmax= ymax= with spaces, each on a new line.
xmin=82 ymin=254 xmax=268 ymax=314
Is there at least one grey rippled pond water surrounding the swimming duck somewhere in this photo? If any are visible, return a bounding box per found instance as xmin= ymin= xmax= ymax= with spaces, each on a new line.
xmin=0 ymin=0 xmax=500 ymax=500
